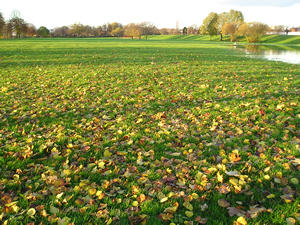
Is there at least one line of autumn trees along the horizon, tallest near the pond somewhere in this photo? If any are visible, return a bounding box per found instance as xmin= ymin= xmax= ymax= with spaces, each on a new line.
xmin=0 ymin=10 xmax=287 ymax=42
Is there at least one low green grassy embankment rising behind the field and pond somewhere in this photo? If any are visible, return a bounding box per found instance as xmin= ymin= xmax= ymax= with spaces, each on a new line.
xmin=148 ymin=35 xmax=300 ymax=45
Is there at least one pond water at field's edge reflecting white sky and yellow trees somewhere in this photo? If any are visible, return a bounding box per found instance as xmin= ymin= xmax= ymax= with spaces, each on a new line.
xmin=232 ymin=45 xmax=300 ymax=64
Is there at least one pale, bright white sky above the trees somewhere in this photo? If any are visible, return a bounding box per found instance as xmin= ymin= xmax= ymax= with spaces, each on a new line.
xmin=0 ymin=0 xmax=300 ymax=29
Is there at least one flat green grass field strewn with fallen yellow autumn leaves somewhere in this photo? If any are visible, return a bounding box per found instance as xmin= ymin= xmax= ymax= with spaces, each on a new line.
xmin=0 ymin=39 xmax=300 ymax=225
